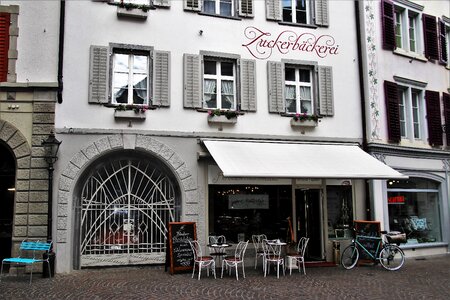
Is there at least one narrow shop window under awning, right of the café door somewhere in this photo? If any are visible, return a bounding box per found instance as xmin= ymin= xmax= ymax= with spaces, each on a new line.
xmin=327 ymin=185 xmax=353 ymax=239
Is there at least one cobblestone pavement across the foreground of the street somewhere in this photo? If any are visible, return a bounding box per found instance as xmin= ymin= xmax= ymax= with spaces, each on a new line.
xmin=0 ymin=255 xmax=450 ymax=300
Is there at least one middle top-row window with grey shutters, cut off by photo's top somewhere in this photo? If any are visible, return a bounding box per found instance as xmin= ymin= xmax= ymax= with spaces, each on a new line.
xmin=184 ymin=0 xmax=253 ymax=18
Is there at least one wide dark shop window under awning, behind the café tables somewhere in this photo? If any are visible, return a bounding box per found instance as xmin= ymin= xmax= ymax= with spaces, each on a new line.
xmin=209 ymin=185 xmax=292 ymax=242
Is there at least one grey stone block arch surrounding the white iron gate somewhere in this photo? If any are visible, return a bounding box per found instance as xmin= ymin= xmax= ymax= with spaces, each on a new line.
xmin=57 ymin=134 xmax=202 ymax=244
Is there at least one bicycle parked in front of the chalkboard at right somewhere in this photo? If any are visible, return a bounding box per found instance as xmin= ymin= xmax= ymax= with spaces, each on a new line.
xmin=341 ymin=231 xmax=406 ymax=271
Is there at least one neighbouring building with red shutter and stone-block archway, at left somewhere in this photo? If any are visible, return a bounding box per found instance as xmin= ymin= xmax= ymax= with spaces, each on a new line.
xmin=0 ymin=1 xmax=59 ymax=259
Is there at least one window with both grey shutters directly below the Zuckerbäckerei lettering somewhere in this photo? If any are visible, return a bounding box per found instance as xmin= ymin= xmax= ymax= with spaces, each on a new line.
xmin=268 ymin=61 xmax=334 ymax=116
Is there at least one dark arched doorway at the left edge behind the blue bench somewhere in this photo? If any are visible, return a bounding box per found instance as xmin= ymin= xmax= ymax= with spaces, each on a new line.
xmin=0 ymin=141 xmax=16 ymax=260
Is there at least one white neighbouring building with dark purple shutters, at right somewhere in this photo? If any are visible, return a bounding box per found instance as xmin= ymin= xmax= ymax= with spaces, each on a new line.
xmin=359 ymin=0 xmax=450 ymax=256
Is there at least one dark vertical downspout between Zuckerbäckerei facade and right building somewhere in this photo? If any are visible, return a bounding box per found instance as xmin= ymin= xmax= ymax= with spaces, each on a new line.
xmin=354 ymin=0 xmax=372 ymax=220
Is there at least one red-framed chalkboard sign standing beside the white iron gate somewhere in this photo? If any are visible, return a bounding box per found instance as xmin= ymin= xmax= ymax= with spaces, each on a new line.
xmin=169 ymin=222 xmax=197 ymax=274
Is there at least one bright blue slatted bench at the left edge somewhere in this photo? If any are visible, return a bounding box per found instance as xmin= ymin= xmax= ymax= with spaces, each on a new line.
xmin=0 ymin=241 xmax=52 ymax=284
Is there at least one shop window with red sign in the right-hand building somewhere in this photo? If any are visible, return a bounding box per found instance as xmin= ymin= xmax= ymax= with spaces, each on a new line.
xmin=387 ymin=178 xmax=442 ymax=245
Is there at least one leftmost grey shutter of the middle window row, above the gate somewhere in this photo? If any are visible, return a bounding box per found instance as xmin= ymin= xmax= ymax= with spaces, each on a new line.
xmin=88 ymin=46 xmax=109 ymax=103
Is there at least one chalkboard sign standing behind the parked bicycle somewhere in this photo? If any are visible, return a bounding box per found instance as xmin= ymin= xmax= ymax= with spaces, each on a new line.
xmin=353 ymin=220 xmax=381 ymax=259
